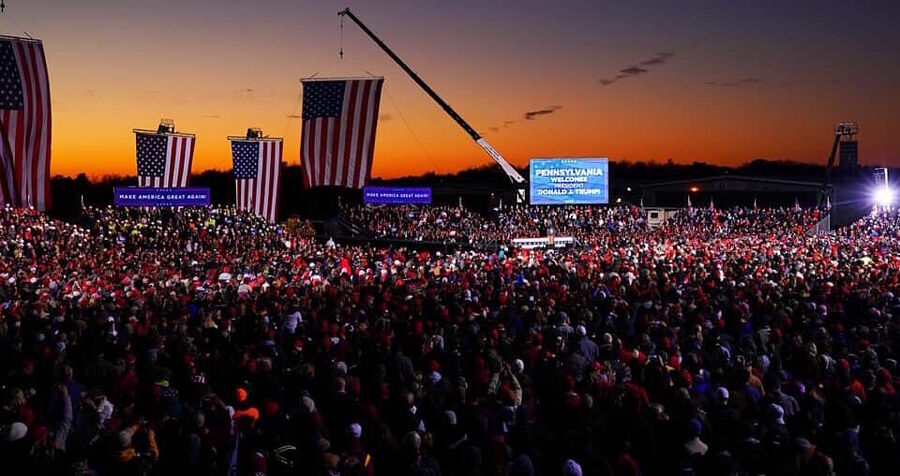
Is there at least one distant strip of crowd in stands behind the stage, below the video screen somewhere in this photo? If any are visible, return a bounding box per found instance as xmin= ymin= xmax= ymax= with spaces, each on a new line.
xmin=343 ymin=205 xmax=823 ymax=247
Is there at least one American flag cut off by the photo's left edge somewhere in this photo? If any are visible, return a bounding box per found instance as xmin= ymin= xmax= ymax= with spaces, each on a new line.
xmin=0 ymin=36 xmax=50 ymax=210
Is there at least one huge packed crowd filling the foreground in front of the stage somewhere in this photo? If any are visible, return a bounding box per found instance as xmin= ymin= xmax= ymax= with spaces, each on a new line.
xmin=0 ymin=203 xmax=900 ymax=476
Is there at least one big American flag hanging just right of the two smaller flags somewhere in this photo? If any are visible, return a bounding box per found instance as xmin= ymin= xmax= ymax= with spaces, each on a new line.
xmin=300 ymin=78 xmax=384 ymax=188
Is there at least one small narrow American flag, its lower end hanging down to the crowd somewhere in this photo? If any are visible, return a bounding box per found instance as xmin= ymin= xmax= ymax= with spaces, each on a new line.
xmin=231 ymin=139 xmax=283 ymax=223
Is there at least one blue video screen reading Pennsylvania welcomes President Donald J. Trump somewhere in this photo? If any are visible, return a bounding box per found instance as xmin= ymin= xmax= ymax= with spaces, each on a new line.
xmin=528 ymin=157 xmax=609 ymax=205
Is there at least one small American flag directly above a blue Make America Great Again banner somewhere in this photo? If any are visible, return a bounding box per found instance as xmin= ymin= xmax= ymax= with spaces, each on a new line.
xmin=134 ymin=131 xmax=196 ymax=187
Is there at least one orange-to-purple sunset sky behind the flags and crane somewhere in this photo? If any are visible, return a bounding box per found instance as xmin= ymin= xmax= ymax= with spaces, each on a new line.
xmin=0 ymin=0 xmax=900 ymax=177
